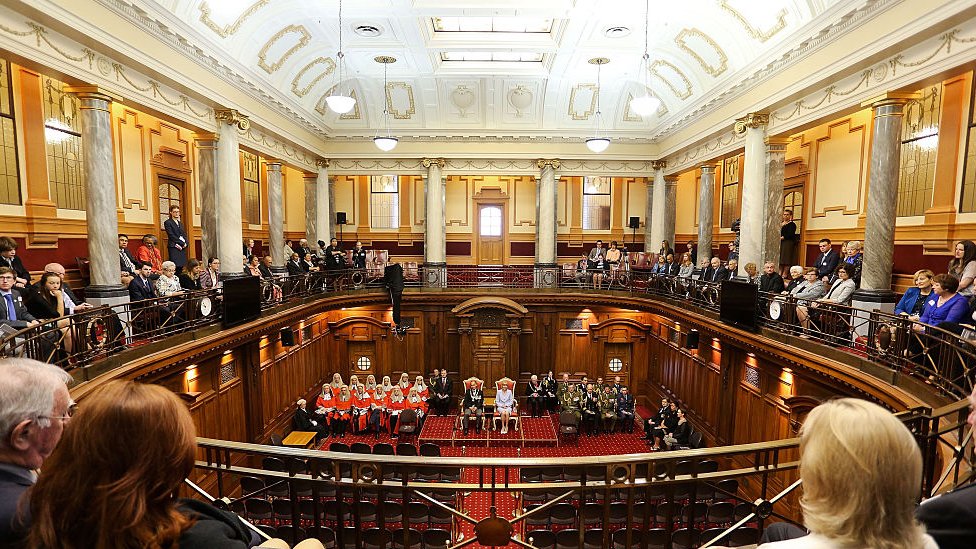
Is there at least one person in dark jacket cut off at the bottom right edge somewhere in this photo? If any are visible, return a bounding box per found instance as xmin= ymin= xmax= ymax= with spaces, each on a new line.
xmin=915 ymin=389 xmax=976 ymax=549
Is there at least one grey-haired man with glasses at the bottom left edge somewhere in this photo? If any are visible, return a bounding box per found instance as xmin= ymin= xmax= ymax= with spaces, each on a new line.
xmin=0 ymin=358 xmax=75 ymax=547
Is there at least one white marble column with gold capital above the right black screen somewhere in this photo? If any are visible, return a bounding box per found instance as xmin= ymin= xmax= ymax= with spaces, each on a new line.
xmin=735 ymin=112 xmax=783 ymax=274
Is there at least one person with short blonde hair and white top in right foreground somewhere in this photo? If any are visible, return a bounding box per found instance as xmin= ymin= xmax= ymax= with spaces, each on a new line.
xmin=760 ymin=398 xmax=944 ymax=549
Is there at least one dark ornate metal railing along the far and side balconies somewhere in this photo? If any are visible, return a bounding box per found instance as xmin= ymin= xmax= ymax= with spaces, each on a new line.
xmin=0 ymin=266 xmax=976 ymax=399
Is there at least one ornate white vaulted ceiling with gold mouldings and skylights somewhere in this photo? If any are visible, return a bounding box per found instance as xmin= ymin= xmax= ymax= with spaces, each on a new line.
xmin=135 ymin=0 xmax=848 ymax=140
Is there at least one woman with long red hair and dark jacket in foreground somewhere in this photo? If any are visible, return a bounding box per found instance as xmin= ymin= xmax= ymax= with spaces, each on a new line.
xmin=28 ymin=381 xmax=304 ymax=549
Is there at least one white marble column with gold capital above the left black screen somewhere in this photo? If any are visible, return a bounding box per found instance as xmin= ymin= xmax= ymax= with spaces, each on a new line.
xmin=214 ymin=109 xmax=251 ymax=277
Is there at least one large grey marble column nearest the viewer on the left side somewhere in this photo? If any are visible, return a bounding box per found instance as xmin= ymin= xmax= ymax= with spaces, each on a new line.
xmin=65 ymin=86 xmax=128 ymax=305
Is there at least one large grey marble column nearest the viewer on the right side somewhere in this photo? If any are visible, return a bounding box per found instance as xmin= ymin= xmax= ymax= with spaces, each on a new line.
xmin=854 ymin=93 xmax=914 ymax=303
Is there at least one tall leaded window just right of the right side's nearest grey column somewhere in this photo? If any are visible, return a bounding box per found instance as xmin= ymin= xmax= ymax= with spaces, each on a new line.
xmin=898 ymin=84 xmax=942 ymax=216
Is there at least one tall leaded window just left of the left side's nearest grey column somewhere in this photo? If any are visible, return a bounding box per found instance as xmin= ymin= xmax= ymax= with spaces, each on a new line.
xmin=44 ymin=78 xmax=86 ymax=210
